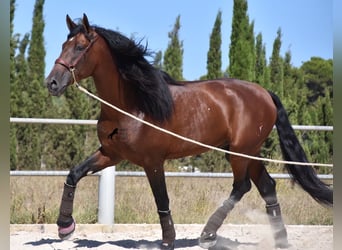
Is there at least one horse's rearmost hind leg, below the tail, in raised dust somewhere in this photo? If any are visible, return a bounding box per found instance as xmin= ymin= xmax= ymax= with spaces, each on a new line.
xmin=249 ymin=161 xmax=288 ymax=248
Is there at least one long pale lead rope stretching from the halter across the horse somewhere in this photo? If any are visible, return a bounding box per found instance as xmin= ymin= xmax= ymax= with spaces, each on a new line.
xmin=70 ymin=68 xmax=333 ymax=167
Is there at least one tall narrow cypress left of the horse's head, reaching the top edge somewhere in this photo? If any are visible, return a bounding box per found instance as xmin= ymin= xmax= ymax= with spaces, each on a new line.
xmin=20 ymin=0 xmax=48 ymax=169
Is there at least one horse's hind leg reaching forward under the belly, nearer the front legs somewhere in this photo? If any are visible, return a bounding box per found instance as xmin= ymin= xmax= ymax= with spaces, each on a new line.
xmin=199 ymin=156 xmax=251 ymax=248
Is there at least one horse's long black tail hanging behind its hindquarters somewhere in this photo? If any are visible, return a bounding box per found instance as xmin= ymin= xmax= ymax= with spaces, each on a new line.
xmin=269 ymin=92 xmax=333 ymax=206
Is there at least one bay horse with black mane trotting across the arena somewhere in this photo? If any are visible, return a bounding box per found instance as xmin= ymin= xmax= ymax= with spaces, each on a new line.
xmin=46 ymin=15 xmax=333 ymax=249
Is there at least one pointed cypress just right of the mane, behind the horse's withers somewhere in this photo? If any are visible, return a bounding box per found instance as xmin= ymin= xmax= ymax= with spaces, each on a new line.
xmin=163 ymin=15 xmax=183 ymax=80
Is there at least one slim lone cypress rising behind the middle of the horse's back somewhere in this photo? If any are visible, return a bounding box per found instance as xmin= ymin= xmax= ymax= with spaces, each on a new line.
xmin=207 ymin=11 xmax=222 ymax=79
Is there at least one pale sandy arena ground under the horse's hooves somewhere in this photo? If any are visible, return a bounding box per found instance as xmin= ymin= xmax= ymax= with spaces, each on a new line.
xmin=10 ymin=224 xmax=333 ymax=250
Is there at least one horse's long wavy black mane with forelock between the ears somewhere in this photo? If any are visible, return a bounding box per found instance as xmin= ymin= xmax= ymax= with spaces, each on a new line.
xmin=68 ymin=25 xmax=177 ymax=122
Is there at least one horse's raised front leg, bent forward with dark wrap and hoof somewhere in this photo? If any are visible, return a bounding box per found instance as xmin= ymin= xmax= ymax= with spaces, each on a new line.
xmin=57 ymin=148 xmax=115 ymax=240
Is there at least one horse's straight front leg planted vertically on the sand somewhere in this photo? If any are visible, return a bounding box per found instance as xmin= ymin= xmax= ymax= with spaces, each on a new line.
xmin=145 ymin=167 xmax=176 ymax=249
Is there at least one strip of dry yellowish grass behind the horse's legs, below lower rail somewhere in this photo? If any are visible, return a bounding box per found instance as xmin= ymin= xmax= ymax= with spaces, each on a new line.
xmin=10 ymin=177 xmax=333 ymax=225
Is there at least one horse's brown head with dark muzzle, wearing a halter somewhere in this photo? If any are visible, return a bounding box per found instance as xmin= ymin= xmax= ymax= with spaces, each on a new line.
xmin=45 ymin=14 xmax=98 ymax=96
